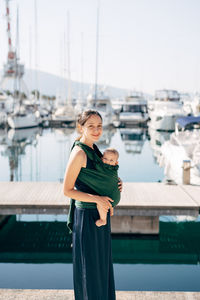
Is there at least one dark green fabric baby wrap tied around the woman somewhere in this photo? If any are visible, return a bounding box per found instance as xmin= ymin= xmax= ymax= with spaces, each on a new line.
xmin=67 ymin=141 xmax=120 ymax=233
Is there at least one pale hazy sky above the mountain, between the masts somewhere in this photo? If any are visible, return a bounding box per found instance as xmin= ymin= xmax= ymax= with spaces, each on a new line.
xmin=0 ymin=0 xmax=200 ymax=93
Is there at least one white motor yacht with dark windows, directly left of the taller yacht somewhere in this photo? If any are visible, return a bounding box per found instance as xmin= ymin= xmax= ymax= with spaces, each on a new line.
xmin=119 ymin=92 xmax=148 ymax=126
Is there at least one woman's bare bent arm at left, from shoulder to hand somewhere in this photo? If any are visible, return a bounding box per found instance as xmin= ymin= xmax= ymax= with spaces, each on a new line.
xmin=63 ymin=146 xmax=113 ymax=210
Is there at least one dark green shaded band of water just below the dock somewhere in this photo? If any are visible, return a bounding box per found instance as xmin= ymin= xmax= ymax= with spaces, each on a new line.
xmin=0 ymin=216 xmax=200 ymax=264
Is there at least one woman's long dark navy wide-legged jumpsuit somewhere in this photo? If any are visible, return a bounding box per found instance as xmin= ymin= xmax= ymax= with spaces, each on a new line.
xmin=73 ymin=147 xmax=116 ymax=300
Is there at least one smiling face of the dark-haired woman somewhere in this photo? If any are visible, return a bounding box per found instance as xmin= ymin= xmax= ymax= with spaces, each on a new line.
xmin=81 ymin=115 xmax=103 ymax=142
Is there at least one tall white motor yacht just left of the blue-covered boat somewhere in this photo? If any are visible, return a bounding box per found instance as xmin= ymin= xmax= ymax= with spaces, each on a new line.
xmin=148 ymin=90 xmax=187 ymax=131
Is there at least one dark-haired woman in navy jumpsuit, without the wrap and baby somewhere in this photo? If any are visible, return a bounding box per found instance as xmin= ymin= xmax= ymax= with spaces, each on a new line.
xmin=64 ymin=110 xmax=121 ymax=300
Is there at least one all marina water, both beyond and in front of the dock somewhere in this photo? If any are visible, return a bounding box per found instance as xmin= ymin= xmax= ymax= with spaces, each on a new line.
xmin=0 ymin=128 xmax=200 ymax=291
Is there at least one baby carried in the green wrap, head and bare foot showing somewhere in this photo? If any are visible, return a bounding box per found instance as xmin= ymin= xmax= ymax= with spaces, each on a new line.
xmin=95 ymin=148 xmax=119 ymax=227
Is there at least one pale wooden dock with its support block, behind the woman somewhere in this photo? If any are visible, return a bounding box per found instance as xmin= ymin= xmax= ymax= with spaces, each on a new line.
xmin=0 ymin=182 xmax=200 ymax=233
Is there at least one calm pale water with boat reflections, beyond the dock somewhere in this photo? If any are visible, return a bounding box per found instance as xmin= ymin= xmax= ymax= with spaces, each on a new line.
xmin=0 ymin=127 xmax=166 ymax=182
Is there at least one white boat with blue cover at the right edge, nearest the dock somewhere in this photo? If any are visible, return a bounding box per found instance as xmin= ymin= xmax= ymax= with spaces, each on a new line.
xmin=158 ymin=116 xmax=200 ymax=185
